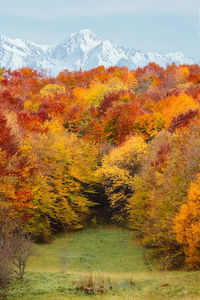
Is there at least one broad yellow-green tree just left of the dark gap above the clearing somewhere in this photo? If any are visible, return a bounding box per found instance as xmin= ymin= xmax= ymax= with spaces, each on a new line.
xmin=24 ymin=121 xmax=96 ymax=239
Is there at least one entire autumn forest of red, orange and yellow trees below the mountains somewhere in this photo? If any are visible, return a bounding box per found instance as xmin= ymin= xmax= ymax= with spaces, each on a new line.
xmin=0 ymin=63 xmax=200 ymax=268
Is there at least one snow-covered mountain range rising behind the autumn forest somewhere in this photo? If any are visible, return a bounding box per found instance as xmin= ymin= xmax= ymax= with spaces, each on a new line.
xmin=0 ymin=29 xmax=199 ymax=75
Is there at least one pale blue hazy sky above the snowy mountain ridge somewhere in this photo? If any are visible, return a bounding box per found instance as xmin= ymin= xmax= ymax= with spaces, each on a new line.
xmin=0 ymin=0 xmax=200 ymax=59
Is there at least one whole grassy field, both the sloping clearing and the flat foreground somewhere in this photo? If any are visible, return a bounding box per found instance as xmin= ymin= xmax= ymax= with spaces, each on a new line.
xmin=3 ymin=227 xmax=200 ymax=300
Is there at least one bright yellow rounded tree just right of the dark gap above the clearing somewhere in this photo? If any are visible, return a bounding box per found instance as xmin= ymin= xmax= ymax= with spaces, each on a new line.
xmin=97 ymin=136 xmax=146 ymax=222
